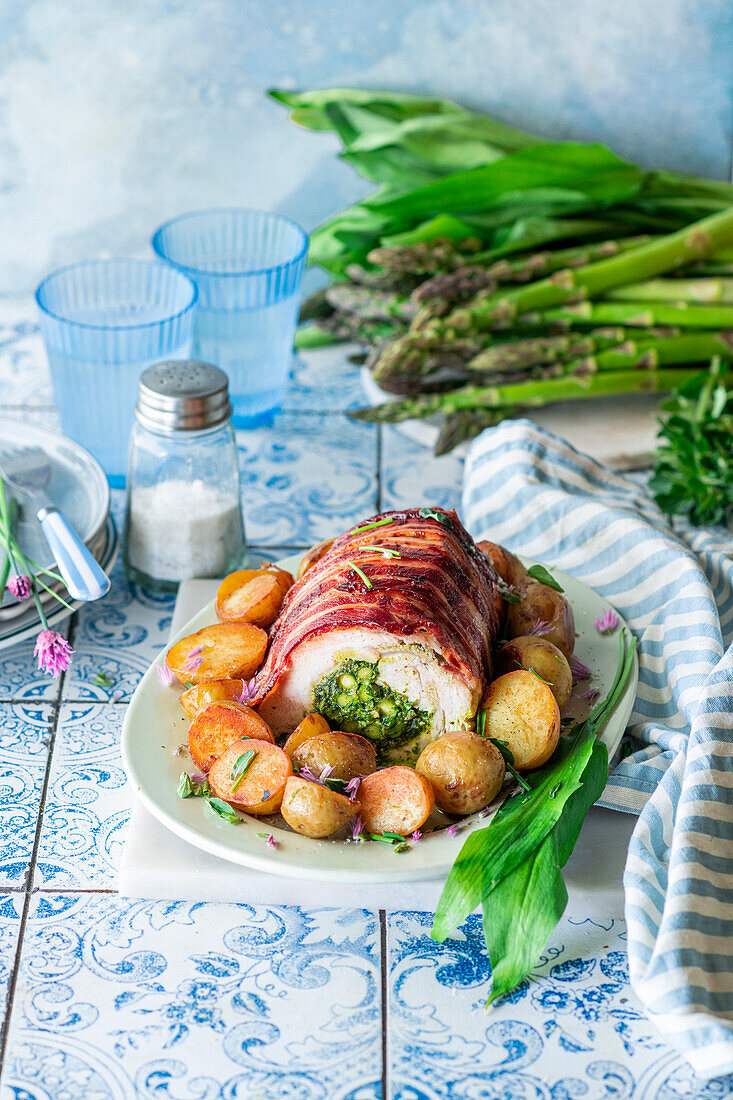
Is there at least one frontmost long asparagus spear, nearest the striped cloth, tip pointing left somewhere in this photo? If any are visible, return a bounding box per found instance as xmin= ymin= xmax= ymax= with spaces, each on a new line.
xmin=348 ymin=367 xmax=713 ymax=424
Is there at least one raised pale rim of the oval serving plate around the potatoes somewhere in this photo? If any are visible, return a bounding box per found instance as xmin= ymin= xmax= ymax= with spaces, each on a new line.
xmin=121 ymin=551 xmax=638 ymax=883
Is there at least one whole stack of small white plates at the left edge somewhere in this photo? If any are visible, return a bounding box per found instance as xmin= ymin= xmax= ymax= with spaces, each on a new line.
xmin=0 ymin=417 xmax=119 ymax=649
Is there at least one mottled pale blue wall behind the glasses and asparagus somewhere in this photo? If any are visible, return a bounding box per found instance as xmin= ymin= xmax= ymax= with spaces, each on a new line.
xmin=0 ymin=0 xmax=733 ymax=294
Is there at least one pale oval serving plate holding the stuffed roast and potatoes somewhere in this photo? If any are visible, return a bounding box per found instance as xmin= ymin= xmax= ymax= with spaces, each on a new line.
xmin=122 ymin=556 xmax=638 ymax=882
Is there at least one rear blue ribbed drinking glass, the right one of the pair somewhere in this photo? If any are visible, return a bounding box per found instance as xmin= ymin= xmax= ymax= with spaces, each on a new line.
xmin=152 ymin=209 xmax=308 ymax=428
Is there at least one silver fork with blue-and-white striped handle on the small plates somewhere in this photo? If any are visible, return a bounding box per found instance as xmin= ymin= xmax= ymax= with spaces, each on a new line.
xmin=0 ymin=447 xmax=109 ymax=601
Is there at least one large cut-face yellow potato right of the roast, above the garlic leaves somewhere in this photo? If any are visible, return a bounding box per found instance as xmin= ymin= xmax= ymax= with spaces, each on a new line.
xmin=484 ymin=669 xmax=560 ymax=771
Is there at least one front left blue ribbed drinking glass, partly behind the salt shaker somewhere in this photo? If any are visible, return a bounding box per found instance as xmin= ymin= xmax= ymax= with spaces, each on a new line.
xmin=35 ymin=260 xmax=197 ymax=486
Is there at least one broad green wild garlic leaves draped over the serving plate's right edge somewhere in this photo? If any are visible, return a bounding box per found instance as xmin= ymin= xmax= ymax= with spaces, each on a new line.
xmin=431 ymin=631 xmax=636 ymax=1003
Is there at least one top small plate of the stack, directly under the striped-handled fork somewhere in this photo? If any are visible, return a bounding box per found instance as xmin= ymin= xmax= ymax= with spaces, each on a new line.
xmin=0 ymin=417 xmax=110 ymax=618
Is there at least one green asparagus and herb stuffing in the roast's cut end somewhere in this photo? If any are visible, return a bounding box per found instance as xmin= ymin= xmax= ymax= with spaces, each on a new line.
xmin=313 ymin=658 xmax=433 ymax=746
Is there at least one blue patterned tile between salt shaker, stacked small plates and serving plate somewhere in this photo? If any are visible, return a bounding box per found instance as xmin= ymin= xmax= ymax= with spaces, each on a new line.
xmin=63 ymin=560 xmax=175 ymax=702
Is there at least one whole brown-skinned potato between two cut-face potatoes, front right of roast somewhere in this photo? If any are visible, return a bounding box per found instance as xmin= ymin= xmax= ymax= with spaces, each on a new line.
xmin=415 ymin=729 xmax=506 ymax=814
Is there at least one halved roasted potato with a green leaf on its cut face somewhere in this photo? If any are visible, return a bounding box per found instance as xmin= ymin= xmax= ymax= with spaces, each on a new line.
xmin=209 ymin=739 xmax=293 ymax=816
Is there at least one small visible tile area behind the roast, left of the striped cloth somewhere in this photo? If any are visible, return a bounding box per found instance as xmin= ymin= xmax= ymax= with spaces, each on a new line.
xmin=382 ymin=425 xmax=463 ymax=510
